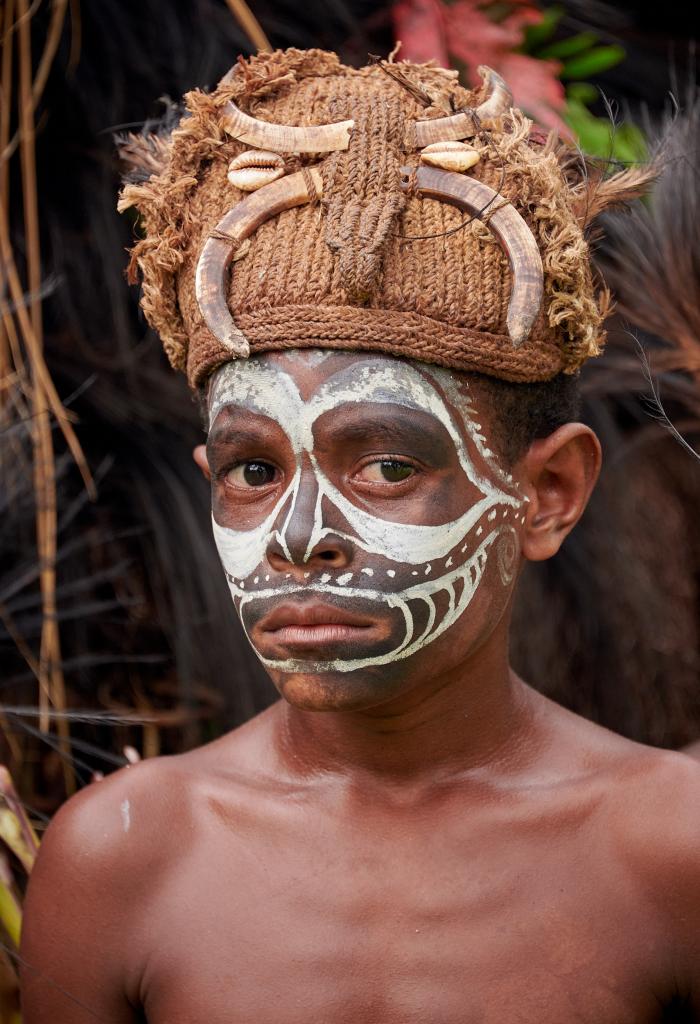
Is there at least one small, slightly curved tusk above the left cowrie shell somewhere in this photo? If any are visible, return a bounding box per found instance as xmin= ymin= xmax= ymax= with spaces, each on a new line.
xmin=222 ymin=100 xmax=355 ymax=153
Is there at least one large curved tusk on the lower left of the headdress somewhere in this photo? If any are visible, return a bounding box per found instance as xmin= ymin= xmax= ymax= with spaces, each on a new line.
xmin=194 ymin=167 xmax=323 ymax=357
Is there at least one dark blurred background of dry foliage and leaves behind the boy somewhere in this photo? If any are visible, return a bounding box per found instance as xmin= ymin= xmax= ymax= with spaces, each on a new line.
xmin=0 ymin=0 xmax=700 ymax=1007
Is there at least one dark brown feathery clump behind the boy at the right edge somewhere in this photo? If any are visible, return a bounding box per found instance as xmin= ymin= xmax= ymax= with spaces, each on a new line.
xmin=514 ymin=90 xmax=700 ymax=745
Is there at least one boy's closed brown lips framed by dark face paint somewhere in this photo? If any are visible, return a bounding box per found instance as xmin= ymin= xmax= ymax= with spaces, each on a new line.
xmin=255 ymin=602 xmax=379 ymax=648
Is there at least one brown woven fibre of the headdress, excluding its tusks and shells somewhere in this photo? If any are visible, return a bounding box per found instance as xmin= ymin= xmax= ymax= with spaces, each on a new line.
xmin=120 ymin=50 xmax=650 ymax=386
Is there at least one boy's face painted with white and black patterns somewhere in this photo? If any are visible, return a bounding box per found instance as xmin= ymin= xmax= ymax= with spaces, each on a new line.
xmin=207 ymin=349 xmax=526 ymax=710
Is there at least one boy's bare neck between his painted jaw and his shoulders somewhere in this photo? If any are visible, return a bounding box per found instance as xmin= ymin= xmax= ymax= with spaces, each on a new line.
xmin=274 ymin=631 xmax=532 ymax=786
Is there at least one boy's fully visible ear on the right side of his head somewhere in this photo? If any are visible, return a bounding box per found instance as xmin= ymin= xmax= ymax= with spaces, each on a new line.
xmin=521 ymin=423 xmax=602 ymax=562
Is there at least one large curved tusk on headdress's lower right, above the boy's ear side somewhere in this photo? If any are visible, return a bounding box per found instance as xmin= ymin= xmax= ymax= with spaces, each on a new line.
xmin=401 ymin=165 xmax=544 ymax=348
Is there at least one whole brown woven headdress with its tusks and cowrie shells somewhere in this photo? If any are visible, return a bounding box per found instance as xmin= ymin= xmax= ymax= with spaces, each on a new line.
xmin=119 ymin=50 xmax=644 ymax=386
